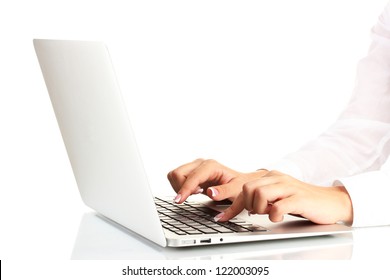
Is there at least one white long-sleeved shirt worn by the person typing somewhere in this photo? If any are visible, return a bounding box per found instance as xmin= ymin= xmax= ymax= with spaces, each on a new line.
xmin=267 ymin=2 xmax=390 ymax=226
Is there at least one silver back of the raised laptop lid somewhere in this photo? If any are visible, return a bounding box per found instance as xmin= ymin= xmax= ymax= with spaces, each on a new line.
xmin=34 ymin=39 xmax=166 ymax=246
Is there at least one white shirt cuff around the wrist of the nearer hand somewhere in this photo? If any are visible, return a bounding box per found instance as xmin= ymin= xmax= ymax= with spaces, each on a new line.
xmin=333 ymin=171 xmax=390 ymax=227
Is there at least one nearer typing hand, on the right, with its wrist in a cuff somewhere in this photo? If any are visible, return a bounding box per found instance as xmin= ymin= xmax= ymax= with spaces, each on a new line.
xmin=216 ymin=171 xmax=353 ymax=224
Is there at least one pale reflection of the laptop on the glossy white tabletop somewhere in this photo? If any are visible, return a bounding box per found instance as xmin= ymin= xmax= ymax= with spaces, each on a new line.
xmin=71 ymin=212 xmax=353 ymax=260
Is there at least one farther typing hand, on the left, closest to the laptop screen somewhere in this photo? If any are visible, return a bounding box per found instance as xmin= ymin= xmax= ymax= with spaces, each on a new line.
xmin=168 ymin=159 xmax=267 ymax=203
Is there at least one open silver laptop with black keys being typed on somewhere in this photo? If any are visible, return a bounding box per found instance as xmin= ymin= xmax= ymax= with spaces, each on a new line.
xmin=34 ymin=39 xmax=350 ymax=247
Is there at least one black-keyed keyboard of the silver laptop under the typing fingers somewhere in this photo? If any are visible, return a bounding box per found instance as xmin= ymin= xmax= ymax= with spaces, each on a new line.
xmin=155 ymin=198 xmax=267 ymax=235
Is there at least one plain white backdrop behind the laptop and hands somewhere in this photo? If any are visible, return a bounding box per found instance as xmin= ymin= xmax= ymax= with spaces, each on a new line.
xmin=0 ymin=0 xmax=387 ymax=279
